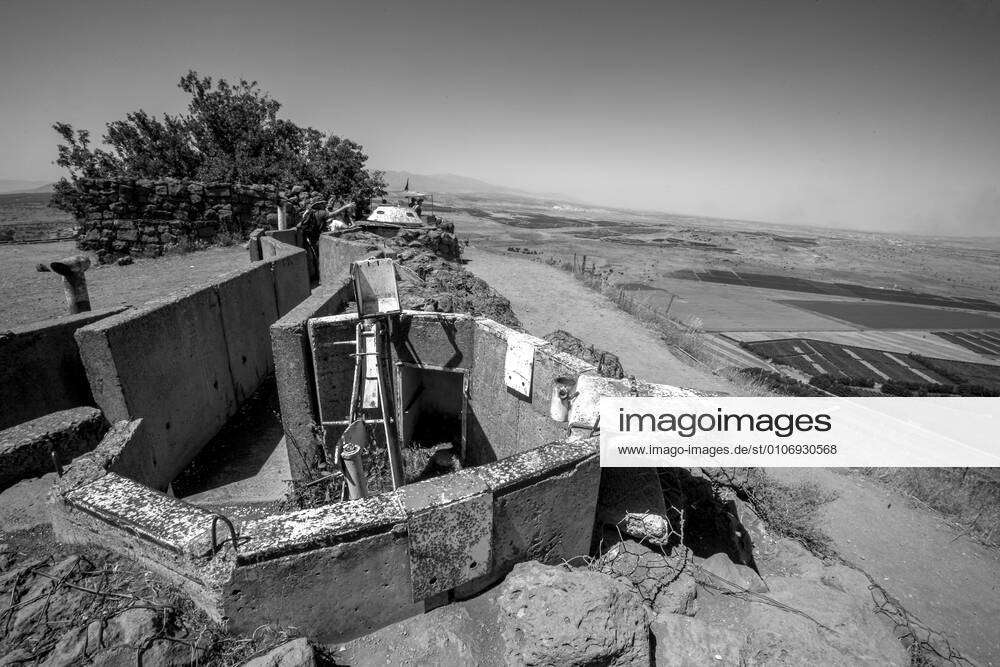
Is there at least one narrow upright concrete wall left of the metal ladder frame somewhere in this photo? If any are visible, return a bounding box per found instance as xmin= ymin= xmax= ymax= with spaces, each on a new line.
xmin=270 ymin=281 xmax=353 ymax=480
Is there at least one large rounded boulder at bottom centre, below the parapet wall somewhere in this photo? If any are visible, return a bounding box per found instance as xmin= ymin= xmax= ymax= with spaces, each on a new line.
xmin=497 ymin=561 xmax=649 ymax=665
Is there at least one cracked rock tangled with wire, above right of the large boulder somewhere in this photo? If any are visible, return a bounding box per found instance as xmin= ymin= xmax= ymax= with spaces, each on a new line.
xmin=597 ymin=540 xmax=698 ymax=616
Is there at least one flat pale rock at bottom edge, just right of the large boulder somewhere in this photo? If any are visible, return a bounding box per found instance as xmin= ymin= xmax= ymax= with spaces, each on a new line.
xmin=649 ymin=614 xmax=746 ymax=667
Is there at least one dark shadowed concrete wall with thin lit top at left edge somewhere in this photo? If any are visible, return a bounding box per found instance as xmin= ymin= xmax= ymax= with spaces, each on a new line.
xmin=0 ymin=308 xmax=123 ymax=429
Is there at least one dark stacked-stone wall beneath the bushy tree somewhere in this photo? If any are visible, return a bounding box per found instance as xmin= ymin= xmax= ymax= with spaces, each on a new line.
xmin=77 ymin=179 xmax=279 ymax=261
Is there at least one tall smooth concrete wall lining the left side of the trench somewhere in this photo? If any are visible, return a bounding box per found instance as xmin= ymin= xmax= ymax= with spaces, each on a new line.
xmin=76 ymin=243 xmax=309 ymax=489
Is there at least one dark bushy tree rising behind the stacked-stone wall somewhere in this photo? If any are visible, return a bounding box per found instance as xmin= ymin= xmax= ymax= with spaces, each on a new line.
xmin=53 ymin=70 xmax=385 ymax=211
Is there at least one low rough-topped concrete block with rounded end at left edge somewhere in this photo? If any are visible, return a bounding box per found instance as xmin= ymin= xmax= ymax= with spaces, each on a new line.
xmin=0 ymin=407 xmax=108 ymax=490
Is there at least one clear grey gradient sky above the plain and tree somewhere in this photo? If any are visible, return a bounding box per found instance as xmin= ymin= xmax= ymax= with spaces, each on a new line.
xmin=0 ymin=0 xmax=1000 ymax=235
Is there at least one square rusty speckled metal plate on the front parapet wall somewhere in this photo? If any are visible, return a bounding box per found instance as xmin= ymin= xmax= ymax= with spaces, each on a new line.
xmin=406 ymin=491 xmax=493 ymax=602
